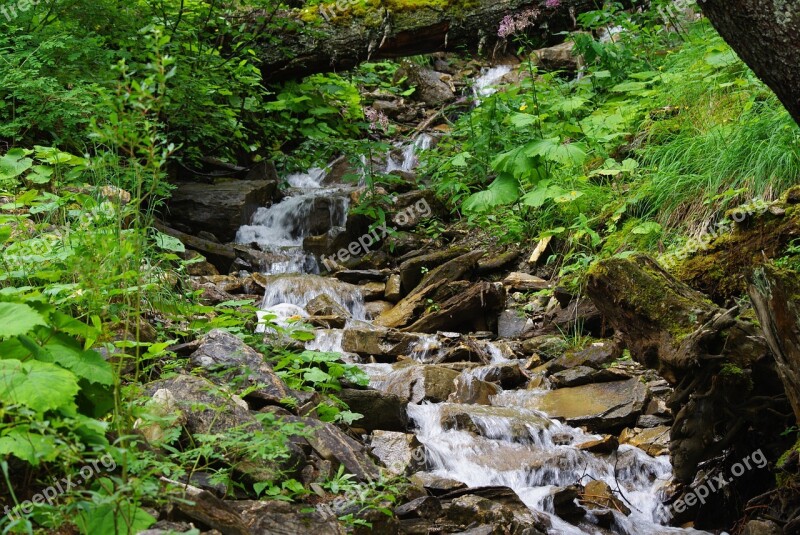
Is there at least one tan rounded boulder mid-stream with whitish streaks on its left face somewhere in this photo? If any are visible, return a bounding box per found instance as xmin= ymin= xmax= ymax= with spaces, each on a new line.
xmin=383 ymin=366 xmax=459 ymax=403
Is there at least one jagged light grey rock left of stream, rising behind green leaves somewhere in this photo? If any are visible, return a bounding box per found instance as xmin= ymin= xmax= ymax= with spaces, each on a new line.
xmin=189 ymin=329 xmax=291 ymax=404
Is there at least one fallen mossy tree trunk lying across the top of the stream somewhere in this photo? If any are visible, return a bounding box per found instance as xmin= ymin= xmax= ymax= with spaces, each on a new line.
xmin=262 ymin=0 xmax=596 ymax=82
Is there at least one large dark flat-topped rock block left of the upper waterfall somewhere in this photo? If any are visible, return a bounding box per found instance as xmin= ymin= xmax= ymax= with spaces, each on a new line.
xmin=166 ymin=179 xmax=278 ymax=242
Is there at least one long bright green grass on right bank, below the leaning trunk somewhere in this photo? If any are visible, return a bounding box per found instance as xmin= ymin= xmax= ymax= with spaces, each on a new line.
xmin=640 ymin=28 xmax=800 ymax=234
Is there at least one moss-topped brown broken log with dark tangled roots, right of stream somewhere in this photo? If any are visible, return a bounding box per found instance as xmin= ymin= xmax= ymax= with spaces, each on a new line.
xmin=587 ymin=255 xmax=788 ymax=483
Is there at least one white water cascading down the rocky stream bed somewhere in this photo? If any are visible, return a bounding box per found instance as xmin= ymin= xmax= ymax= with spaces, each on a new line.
xmin=237 ymin=135 xmax=700 ymax=535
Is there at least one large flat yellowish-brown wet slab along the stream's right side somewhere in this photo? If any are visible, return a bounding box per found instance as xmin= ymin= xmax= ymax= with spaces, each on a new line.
xmin=528 ymin=379 xmax=648 ymax=432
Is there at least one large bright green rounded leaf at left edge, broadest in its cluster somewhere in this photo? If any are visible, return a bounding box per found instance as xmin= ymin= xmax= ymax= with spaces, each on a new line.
xmin=0 ymin=359 xmax=79 ymax=412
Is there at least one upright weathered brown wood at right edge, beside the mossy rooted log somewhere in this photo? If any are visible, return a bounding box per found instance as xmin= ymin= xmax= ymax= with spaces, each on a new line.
xmin=750 ymin=265 xmax=800 ymax=423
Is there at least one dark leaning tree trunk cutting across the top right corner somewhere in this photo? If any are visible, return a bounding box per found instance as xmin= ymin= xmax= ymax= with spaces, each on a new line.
xmin=698 ymin=0 xmax=800 ymax=123
